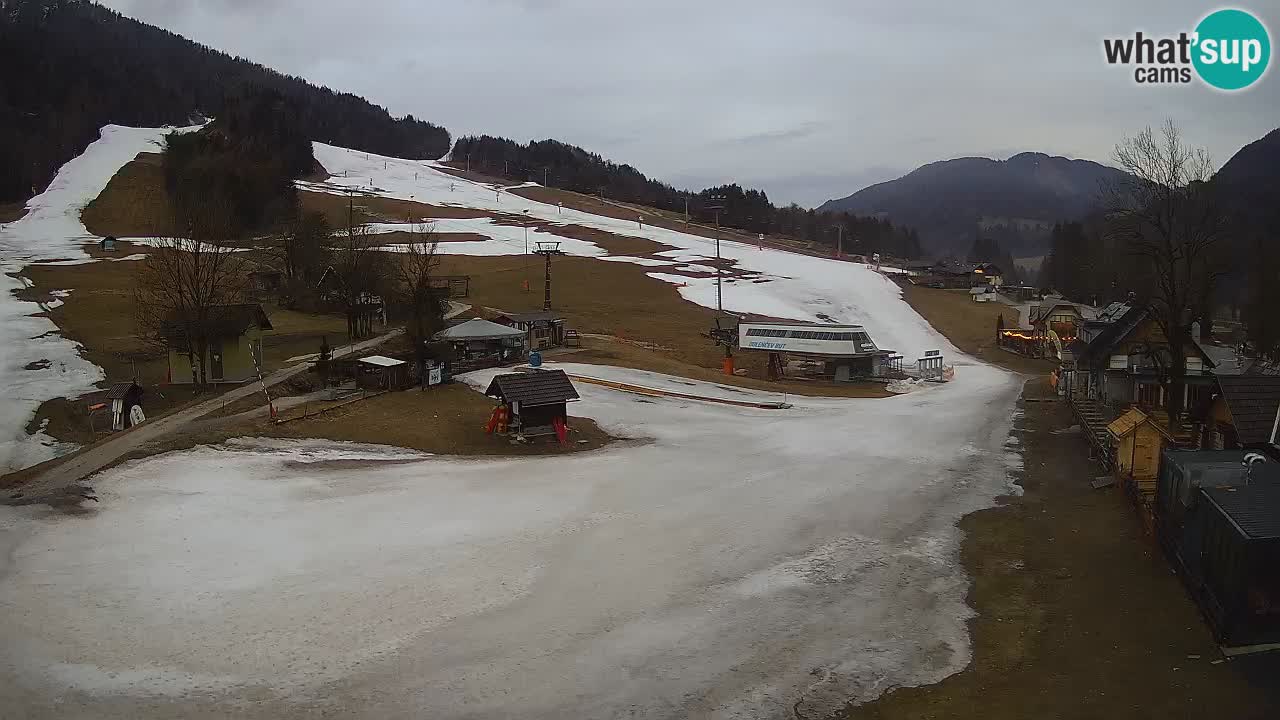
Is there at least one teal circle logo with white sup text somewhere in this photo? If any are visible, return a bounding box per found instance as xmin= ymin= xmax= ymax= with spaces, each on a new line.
xmin=1192 ymin=9 xmax=1271 ymax=90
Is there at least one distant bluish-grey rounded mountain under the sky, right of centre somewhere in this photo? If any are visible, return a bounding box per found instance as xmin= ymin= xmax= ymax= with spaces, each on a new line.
xmin=819 ymin=152 xmax=1124 ymax=256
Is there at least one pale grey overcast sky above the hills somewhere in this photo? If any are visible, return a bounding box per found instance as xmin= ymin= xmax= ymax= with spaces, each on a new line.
xmin=104 ymin=0 xmax=1280 ymax=205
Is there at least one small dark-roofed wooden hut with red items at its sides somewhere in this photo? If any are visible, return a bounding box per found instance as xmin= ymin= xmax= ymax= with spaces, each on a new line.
xmin=485 ymin=370 xmax=579 ymax=442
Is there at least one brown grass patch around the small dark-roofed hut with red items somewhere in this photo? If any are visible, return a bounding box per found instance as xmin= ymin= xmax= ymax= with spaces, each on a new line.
xmin=257 ymin=383 xmax=613 ymax=455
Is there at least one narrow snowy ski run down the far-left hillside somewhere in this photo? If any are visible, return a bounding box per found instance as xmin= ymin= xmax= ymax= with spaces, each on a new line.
xmin=0 ymin=126 xmax=194 ymax=471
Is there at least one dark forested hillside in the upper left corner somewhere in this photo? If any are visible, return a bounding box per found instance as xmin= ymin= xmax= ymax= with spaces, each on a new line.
xmin=0 ymin=0 xmax=449 ymax=201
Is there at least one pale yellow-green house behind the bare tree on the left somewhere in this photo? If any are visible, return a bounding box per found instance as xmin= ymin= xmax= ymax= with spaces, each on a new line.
xmin=161 ymin=302 xmax=273 ymax=383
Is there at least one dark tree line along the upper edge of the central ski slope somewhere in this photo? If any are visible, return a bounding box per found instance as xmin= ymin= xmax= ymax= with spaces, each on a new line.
xmin=452 ymin=136 xmax=920 ymax=258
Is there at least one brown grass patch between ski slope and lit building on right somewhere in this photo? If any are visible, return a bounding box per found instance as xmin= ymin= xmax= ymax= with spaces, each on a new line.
xmin=902 ymin=284 xmax=1056 ymax=374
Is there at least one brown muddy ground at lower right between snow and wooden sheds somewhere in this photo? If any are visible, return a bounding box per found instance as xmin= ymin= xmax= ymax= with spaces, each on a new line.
xmin=840 ymin=379 xmax=1280 ymax=720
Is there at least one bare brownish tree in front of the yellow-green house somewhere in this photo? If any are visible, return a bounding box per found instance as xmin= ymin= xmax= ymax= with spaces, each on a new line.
xmin=133 ymin=208 xmax=247 ymax=386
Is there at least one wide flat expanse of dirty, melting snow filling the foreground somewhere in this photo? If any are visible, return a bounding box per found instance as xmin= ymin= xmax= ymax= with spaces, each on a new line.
xmin=0 ymin=365 xmax=1019 ymax=719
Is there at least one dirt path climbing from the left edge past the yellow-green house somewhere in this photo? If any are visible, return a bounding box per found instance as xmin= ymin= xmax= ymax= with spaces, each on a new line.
xmin=6 ymin=328 xmax=403 ymax=503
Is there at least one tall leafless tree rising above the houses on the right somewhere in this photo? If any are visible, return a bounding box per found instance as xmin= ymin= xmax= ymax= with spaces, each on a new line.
xmin=1105 ymin=120 xmax=1226 ymax=427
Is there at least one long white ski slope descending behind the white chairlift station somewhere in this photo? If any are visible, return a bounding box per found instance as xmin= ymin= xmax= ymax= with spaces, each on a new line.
xmin=298 ymin=142 xmax=959 ymax=363
